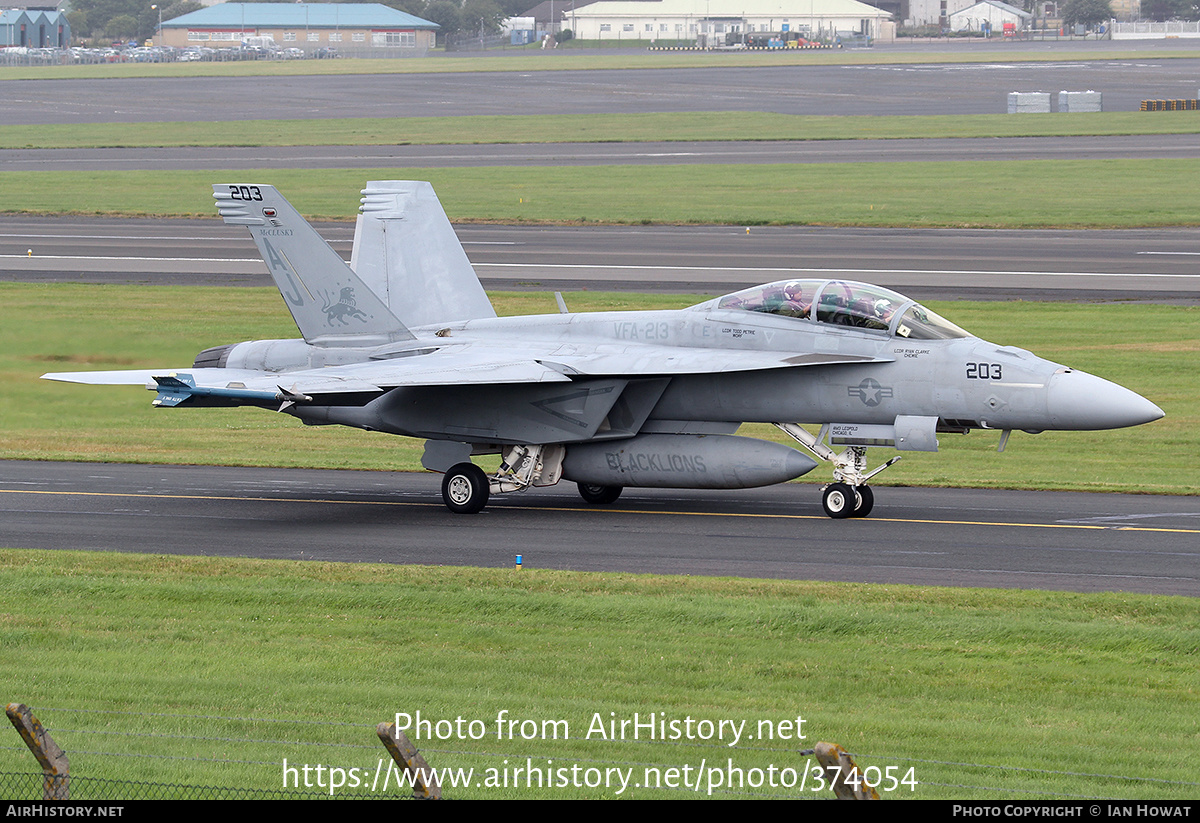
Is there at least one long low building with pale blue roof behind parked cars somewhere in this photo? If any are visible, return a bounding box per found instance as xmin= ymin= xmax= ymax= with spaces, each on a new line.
xmin=162 ymin=2 xmax=440 ymax=56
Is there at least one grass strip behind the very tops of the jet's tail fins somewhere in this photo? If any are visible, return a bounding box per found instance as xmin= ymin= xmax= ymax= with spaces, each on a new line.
xmin=7 ymin=160 xmax=1200 ymax=229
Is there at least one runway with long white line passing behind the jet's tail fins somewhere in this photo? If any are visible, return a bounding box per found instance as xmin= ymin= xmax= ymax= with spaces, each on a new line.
xmin=0 ymin=216 xmax=1200 ymax=302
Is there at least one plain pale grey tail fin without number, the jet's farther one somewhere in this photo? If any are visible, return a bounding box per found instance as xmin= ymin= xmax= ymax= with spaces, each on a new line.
xmin=350 ymin=180 xmax=496 ymax=326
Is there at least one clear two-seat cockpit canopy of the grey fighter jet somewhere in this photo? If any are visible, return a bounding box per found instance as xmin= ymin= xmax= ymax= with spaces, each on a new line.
xmin=697 ymin=280 xmax=971 ymax=340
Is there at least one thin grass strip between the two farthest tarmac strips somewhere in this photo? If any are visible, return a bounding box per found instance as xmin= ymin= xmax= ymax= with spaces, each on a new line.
xmin=0 ymin=112 xmax=1200 ymax=149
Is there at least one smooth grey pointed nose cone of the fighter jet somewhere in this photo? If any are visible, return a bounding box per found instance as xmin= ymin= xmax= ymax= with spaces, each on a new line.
xmin=1046 ymin=371 xmax=1163 ymax=431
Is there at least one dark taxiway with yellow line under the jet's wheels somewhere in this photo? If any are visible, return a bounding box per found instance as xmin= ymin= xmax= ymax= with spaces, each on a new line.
xmin=0 ymin=461 xmax=1200 ymax=596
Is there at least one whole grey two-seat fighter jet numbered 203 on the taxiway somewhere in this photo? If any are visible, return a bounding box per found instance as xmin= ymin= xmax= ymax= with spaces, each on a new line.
xmin=44 ymin=181 xmax=1163 ymax=518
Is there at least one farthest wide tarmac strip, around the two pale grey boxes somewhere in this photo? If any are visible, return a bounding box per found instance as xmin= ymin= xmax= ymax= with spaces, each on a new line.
xmin=0 ymin=53 xmax=1200 ymax=124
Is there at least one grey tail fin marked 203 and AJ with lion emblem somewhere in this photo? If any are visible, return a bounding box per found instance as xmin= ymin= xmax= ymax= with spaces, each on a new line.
xmin=212 ymin=184 xmax=413 ymax=346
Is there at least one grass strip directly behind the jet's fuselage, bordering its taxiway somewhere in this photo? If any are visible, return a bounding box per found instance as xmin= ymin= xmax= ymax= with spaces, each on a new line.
xmin=0 ymin=283 xmax=1200 ymax=494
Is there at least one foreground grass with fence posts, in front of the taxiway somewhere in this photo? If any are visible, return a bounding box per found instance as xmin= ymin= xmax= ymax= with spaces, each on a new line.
xmin=0 ymin=551 xmax=1200 ymax=801
